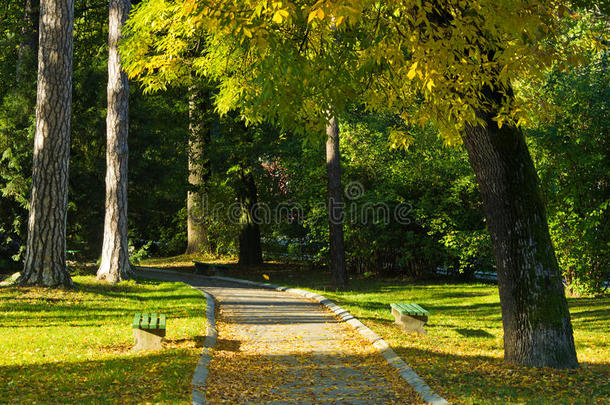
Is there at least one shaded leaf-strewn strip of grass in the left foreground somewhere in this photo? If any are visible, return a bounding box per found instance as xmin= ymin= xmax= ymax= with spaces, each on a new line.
xmin=0 ymin=349 xmax=198 ymax=404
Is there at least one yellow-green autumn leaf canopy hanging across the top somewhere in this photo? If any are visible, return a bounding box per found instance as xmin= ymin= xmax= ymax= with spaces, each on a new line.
xmin=123 ymin=0 xmax=603 ymax=146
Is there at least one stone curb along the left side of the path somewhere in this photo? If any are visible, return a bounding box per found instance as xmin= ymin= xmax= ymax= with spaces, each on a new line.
xmin=133 ymin=268 xmax=218 ymax=405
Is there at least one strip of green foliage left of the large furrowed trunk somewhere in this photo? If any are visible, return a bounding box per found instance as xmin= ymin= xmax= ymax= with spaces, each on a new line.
xmin=0 ymin=0 xmax=40 ymax=258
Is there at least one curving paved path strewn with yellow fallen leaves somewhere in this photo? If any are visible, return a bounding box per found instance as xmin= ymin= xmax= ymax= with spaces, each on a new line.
xmin=142 ymin=272 xmax=421 ymax=404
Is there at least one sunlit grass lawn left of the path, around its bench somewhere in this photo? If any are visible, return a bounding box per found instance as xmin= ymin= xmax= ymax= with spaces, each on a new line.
xmin=0 ymin=276 xmax=205 ymax=404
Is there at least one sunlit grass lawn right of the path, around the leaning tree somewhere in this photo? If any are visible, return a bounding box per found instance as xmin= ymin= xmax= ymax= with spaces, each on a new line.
xmin=144 ymin=263 xmax=610 ymax=405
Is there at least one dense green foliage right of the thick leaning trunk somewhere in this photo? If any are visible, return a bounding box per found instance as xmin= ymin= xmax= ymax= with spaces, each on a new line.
xmin=525 ymin=41 xmax=610 ymax=295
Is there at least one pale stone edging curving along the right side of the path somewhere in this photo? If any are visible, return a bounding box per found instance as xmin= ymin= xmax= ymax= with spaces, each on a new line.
xmin=210 ymin=276 xmax=449 ymax=405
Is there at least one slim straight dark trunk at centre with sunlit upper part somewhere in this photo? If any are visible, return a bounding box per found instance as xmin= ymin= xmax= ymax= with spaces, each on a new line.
xmin=326 ymin=117 xmax=348 ymax=289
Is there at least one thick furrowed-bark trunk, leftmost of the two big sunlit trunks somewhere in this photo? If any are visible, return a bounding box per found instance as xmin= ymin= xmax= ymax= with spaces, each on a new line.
xmin=19 ymin=0 xmax=74 ymax=287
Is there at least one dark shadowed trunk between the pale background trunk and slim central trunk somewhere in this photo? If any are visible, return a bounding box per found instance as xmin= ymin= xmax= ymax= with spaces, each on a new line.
xmin=237 ymin=168 xmax=263 ymax=266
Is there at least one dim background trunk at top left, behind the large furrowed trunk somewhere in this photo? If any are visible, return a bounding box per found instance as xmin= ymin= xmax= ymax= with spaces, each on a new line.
xmin=16 ymin=0 xmax=40 ymax=82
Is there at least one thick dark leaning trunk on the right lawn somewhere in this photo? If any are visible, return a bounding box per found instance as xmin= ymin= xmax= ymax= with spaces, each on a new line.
xmin=463 ymin=109 xmax=578 ymax=368
